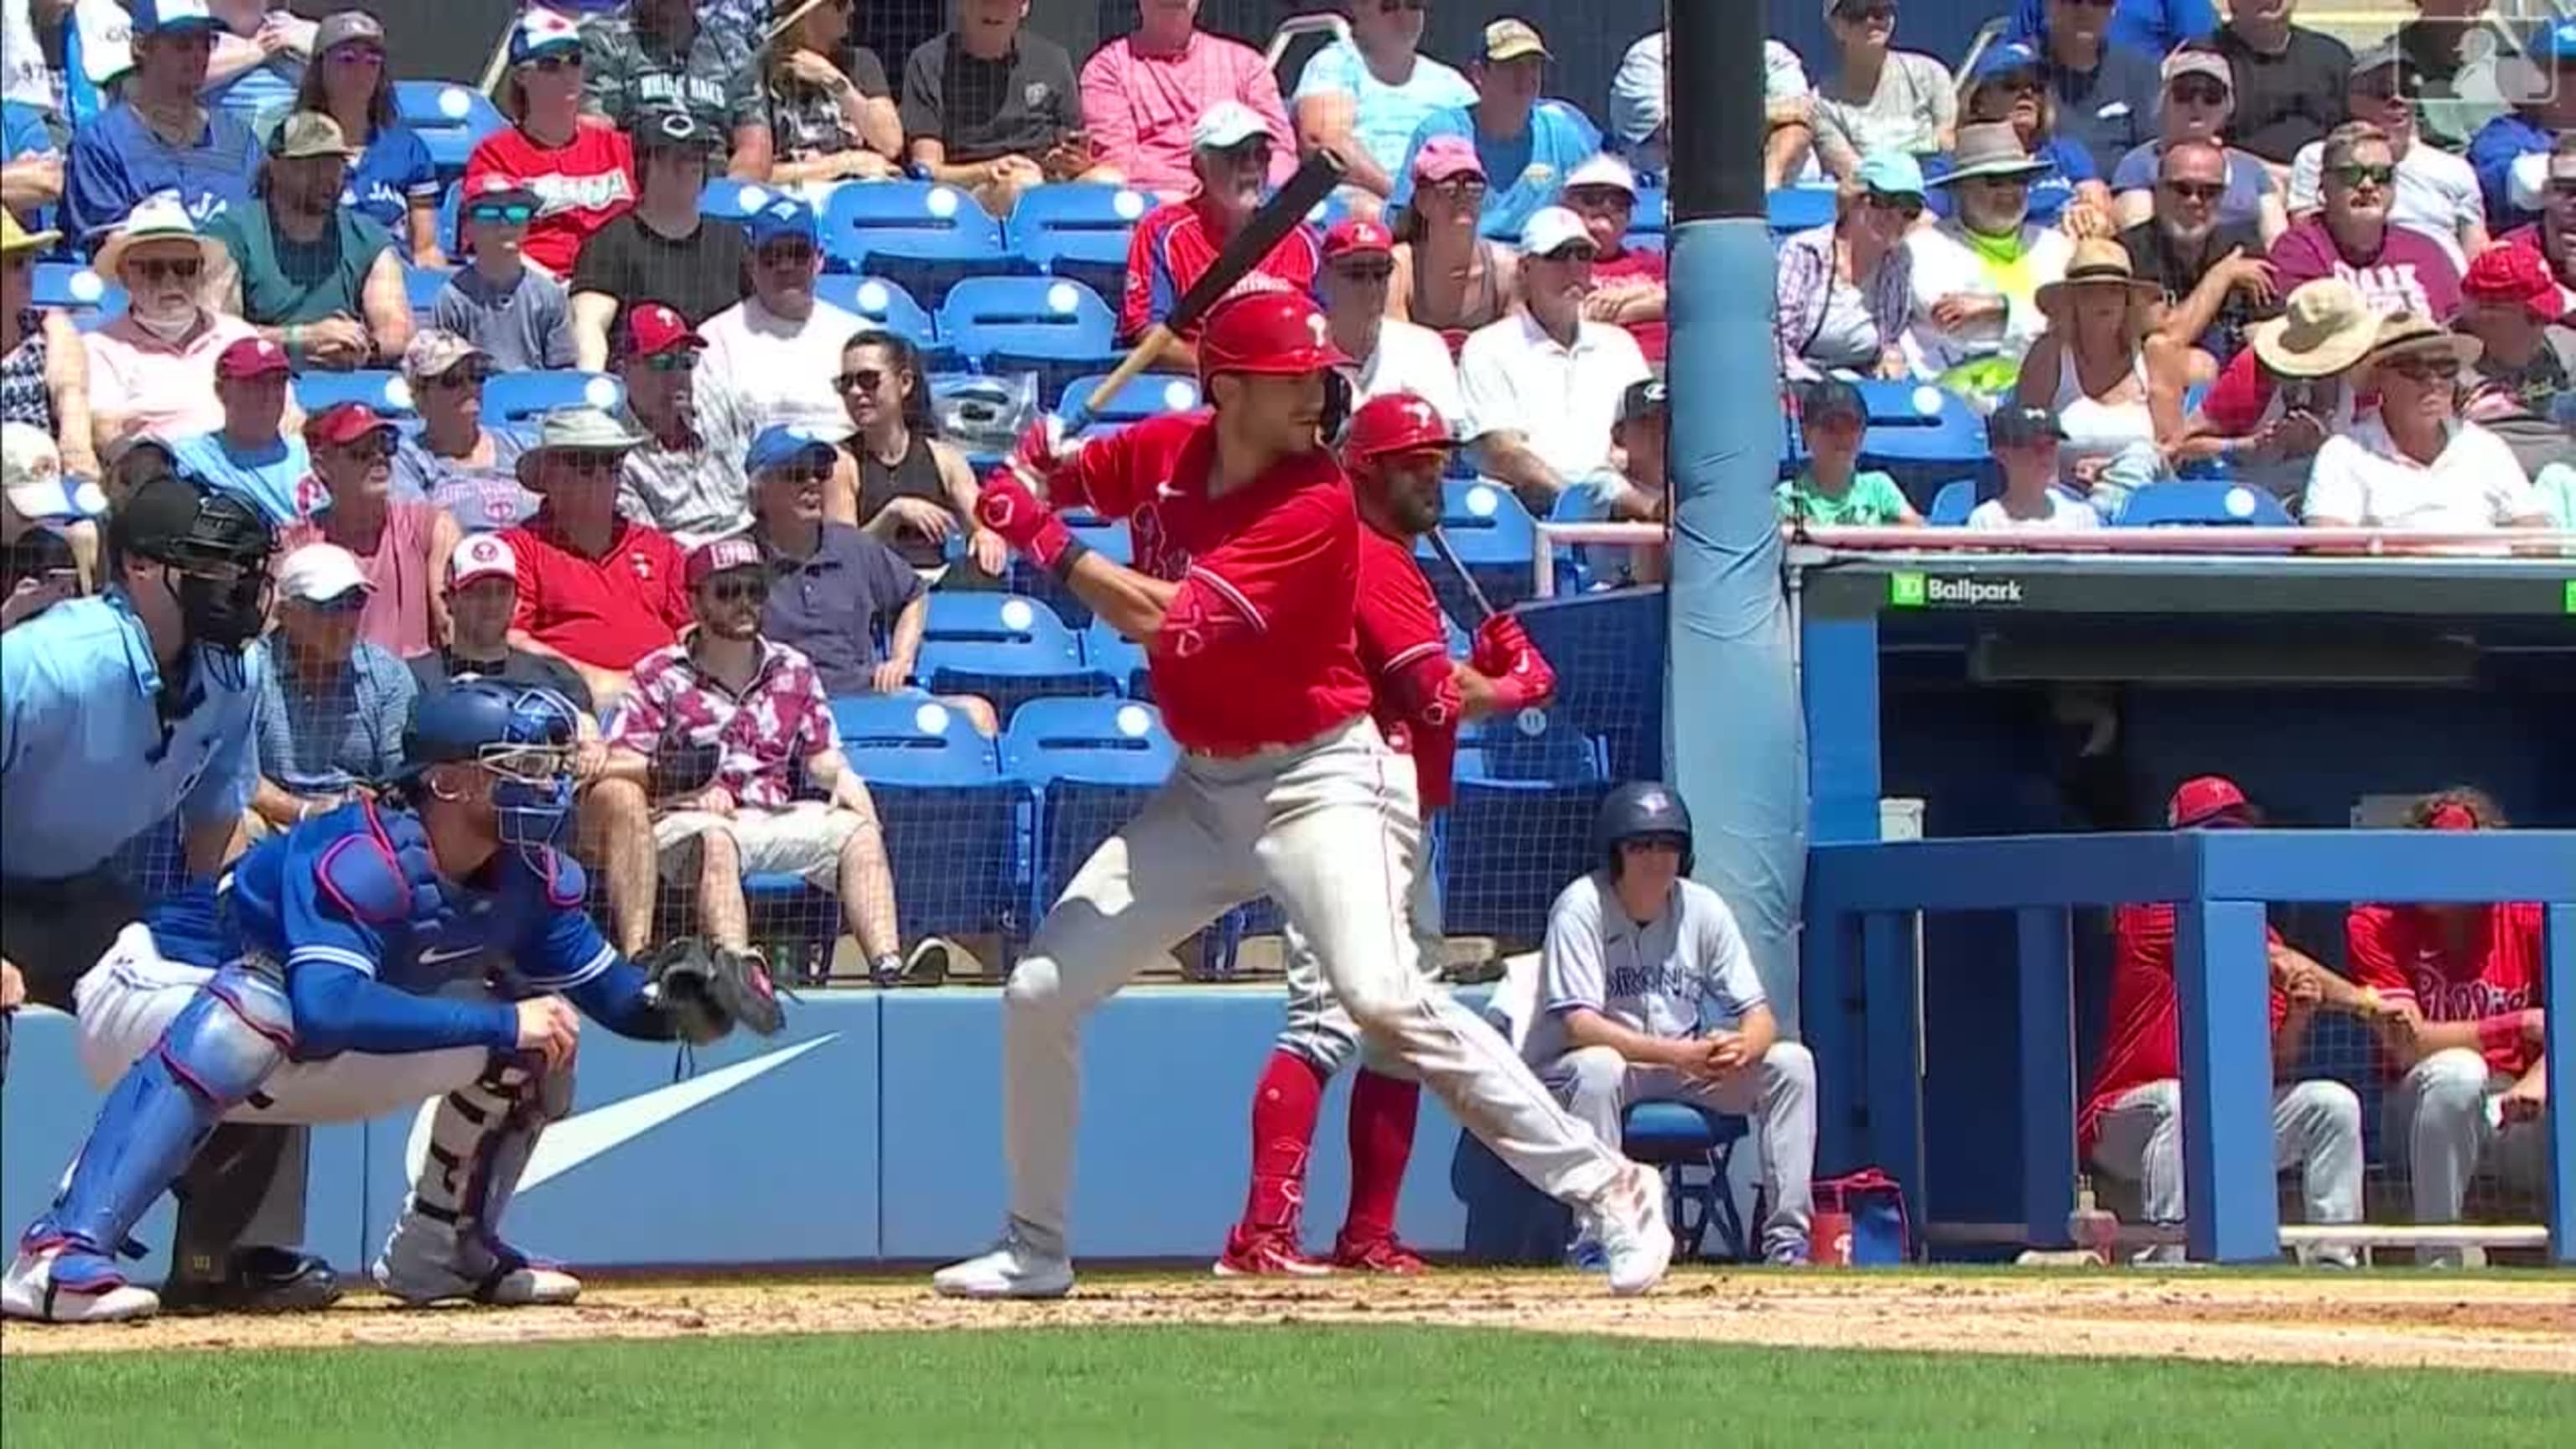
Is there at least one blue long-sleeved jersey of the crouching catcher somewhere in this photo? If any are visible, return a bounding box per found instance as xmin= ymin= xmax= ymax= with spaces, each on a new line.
xmin=144 ymin=802 xmax=618 ymax=998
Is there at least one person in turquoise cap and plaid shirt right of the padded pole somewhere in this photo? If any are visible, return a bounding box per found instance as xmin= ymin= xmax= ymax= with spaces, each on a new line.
xmin=1773 ymin=152 xmax=1924 ymax=382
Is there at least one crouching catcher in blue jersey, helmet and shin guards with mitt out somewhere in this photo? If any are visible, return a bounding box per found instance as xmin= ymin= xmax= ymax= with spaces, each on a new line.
xmin=0 ymin=681 xmax=783 ymax=1322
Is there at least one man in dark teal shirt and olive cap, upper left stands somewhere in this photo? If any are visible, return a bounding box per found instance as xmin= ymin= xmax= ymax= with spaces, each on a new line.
xmin=206 ymin=111 xmax=413 ymax=371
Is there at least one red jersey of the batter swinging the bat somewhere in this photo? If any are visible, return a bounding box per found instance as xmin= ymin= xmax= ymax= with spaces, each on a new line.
xmin=1048 ymin=413 xmax=1368 ymax=756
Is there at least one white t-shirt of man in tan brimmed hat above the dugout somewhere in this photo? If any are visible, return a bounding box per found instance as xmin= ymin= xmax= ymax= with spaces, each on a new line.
xmin=2303 ymin=418 xmax=2542 ymax=533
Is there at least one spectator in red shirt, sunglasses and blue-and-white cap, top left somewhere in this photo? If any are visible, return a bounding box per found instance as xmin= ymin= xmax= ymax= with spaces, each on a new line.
xmin=464 ymin=8 xmax=636 ymax=278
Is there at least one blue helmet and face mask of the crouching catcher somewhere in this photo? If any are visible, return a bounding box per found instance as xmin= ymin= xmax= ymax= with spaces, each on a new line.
xmin=402 ymin=678 xmax=579 ymax=846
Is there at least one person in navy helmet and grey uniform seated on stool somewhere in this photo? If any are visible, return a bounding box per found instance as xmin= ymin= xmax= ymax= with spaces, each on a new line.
xmin=1525 ymin=782 xmax=1816 ymax=1264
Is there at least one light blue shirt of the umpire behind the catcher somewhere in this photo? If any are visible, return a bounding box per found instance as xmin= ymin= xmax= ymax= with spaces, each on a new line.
xmin=0 ymin=590 xmax=267 ymax=879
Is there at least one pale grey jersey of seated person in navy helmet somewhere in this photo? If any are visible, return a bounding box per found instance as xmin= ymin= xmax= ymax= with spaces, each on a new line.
xmin=1523 ymin=871 xmax=1769 ymax=1065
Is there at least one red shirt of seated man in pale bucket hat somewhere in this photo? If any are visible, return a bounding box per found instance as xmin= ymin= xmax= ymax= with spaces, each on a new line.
xmin=502 ymin=508 xmax=688 ymax=670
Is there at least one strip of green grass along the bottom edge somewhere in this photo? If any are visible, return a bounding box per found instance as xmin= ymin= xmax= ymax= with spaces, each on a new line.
xmin=0 ymin=1327 xmax=2576 ymax=1449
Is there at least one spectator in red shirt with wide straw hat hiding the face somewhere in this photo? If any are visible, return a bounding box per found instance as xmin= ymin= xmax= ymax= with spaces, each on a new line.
xmin=2174 ymin=276 xmax=2381 ymax=503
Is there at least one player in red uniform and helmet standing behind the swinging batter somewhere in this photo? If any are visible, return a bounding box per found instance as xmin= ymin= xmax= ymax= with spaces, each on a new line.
xmin=1216 ymin=392 xmax=1555 ymax=1276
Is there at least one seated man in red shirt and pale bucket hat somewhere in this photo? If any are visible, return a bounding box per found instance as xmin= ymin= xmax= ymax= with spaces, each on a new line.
xmin=502 ymin=408 xmax=688 ymax=706
